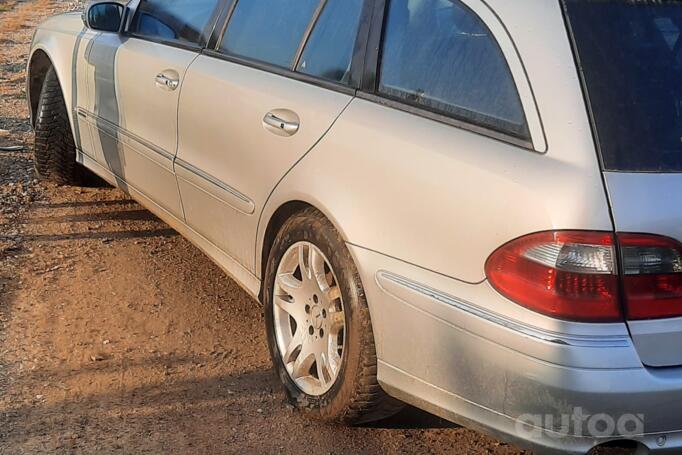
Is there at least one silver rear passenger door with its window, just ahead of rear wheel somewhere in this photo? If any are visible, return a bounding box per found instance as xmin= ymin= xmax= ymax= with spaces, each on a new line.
xmin=175 ymin=0 xmax=368 ymax=271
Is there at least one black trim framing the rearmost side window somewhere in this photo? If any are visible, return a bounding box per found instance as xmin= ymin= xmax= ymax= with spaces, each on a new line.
xmin=364 ymin=0 xmax=537 ymax=152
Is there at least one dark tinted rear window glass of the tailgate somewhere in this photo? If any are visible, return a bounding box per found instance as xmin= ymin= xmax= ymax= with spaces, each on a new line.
xmin=564 ymin=0 xmax=682 ymax=172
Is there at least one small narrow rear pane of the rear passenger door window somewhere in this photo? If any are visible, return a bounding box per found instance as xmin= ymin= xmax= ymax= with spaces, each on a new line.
xmin=296 ymin=0 xmax=364 ymax=83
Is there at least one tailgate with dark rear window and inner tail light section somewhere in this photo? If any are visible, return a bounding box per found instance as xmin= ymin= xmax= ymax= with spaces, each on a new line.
xmin=564 ymin=0 xmax=682 ymax=367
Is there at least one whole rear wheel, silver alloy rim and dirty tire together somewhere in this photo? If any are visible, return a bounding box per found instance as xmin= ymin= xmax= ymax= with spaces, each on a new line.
xmin=264 ymin=208 xmax=403 ymax=424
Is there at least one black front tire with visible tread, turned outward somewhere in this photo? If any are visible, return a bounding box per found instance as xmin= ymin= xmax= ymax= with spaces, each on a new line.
xmin=33 ymin=68 xmax=85 ymax=186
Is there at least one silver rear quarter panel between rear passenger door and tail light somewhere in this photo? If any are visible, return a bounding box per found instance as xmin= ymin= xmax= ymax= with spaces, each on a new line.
xmin=262 ymin=99 xmax=612 ymax=283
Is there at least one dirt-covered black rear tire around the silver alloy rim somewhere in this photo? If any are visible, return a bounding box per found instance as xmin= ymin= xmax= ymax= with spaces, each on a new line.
xmin=263 ymin=208 xmax=404 ymax=425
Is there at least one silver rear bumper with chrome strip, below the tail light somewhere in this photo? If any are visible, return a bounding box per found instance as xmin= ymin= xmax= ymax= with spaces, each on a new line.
xmin=351 ymin=247 xmax=682 ymax=454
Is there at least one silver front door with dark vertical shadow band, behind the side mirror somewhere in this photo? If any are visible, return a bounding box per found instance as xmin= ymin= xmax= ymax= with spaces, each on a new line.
xmin=84 ymin=0 xmax=222 ymax=219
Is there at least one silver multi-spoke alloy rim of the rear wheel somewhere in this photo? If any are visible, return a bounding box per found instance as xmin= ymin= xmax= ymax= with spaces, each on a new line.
xmin=273 ymin=242 xmax=346 ymax=396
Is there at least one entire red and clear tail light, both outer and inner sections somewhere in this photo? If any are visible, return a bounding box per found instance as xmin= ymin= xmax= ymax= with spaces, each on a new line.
xmin=486 ymin=231 xmax=682 ymax=322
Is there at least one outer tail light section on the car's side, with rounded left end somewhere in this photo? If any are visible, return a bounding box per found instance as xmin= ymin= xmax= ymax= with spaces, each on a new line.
xmin=486 ymin=231 xmax=622 ymax=322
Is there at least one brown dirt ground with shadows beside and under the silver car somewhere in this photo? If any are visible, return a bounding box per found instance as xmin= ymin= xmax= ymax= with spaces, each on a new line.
xmin=0 ymin=0 xmax=620 ymax=455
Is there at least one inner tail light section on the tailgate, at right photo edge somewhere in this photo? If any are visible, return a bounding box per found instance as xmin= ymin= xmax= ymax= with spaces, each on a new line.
xmin=618 ymin=234 xmax=682 ymax=320
